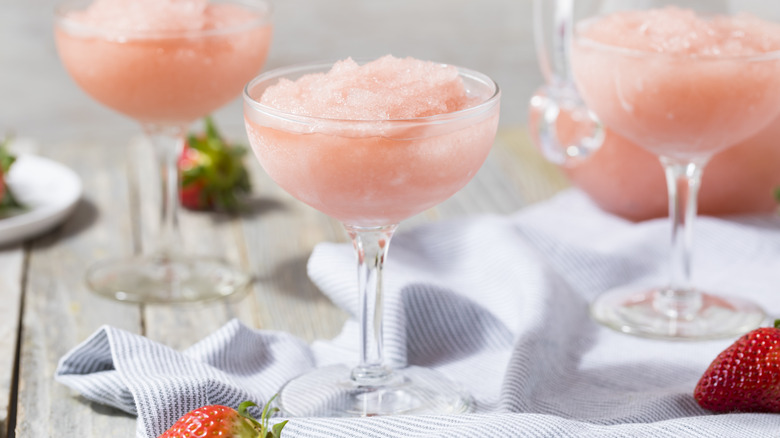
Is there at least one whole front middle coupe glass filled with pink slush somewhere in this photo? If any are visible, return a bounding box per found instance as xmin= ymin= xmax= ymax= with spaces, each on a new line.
xmin=244 ymin=56 xmax=500 ymax=417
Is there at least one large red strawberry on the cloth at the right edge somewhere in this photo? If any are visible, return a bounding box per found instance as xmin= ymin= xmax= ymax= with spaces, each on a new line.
xmin=693 ymin=320 xmax=780 ymax=412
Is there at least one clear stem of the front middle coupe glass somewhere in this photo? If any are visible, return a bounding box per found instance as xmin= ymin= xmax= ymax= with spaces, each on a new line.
xmin=345 ymin=225 xmax=398 ymax=386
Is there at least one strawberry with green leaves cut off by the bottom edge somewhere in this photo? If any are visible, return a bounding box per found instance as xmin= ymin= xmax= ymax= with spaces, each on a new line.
xmin=158 ymin=396 xmax=287 ymax=438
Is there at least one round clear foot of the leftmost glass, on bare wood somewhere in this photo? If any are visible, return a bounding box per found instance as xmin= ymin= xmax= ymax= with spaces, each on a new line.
xmin=86 ymin=255 xmax=249 ymax=303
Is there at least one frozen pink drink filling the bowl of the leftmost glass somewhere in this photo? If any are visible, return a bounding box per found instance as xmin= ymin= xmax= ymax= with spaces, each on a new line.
xmin=55 ymin=0 xmax=272 ymax=124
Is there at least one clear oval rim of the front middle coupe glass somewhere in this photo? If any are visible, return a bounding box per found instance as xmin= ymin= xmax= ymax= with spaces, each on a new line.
xmin=243 ymin=58 xmax=501 ymax=125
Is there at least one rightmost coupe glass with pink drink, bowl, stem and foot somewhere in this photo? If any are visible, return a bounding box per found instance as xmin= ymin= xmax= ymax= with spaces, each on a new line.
xmin=563 ymin=0 xmax=780 ymax=340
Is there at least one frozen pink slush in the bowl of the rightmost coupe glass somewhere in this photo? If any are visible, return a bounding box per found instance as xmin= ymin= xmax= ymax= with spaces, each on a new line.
xmin=572 ymin=7 xmax=780 ymax=159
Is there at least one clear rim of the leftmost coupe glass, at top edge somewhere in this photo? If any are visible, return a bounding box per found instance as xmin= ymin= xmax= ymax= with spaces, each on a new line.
xmin=54 ymin=0 xmax=274 ymax=41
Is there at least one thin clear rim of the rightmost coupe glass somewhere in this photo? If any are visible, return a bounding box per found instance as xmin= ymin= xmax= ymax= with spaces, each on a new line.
xmin=574 ymin=16 xmax=780 ymax=62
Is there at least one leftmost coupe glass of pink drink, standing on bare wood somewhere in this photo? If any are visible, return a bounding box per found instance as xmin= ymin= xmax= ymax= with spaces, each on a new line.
xmin=55 ymin=0 xmax=272 ymax=302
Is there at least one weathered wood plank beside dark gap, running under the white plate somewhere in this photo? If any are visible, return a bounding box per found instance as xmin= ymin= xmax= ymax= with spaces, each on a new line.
xmin=15 ymin=139 xmax=141 ymax=438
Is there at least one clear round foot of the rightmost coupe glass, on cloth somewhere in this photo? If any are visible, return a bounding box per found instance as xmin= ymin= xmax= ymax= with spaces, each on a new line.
xmin=590 ymin=289 xmax=766 ymax=341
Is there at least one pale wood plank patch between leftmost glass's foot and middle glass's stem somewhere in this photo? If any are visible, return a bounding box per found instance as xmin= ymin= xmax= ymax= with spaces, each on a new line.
xmin=243 ymin=158 xmax=346 ymax=341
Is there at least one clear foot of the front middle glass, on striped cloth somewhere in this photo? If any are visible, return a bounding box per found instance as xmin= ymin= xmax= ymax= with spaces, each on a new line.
xmin=279 ymin=365 xmax=473 ymax=417
